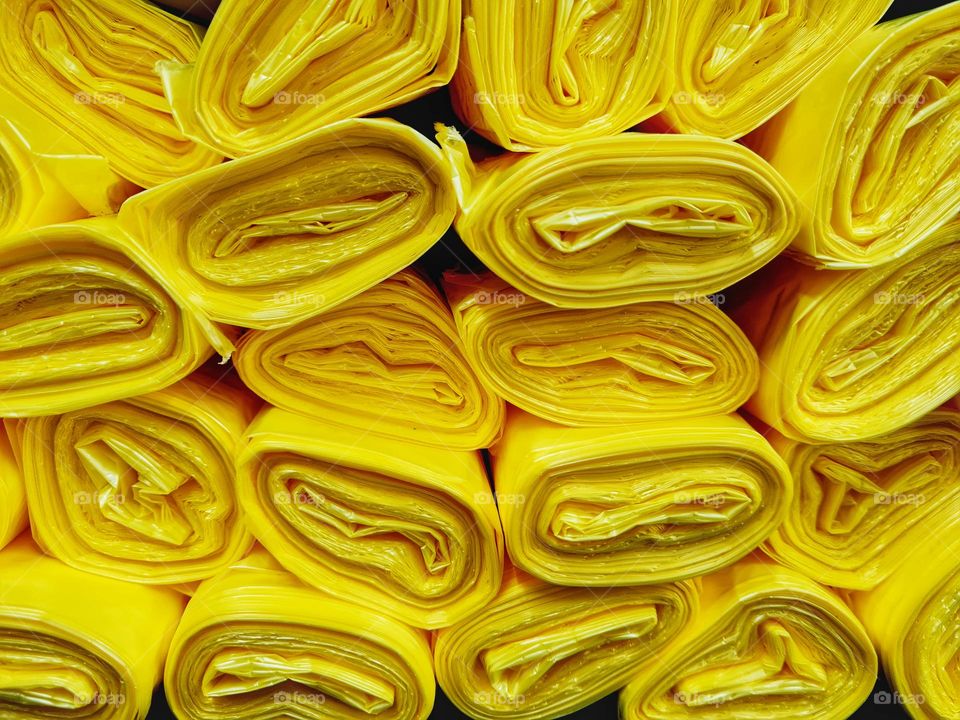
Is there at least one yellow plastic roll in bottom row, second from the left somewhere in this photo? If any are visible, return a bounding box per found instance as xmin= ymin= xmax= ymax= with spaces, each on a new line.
xmin=164 ymin=550 xmax=436 ymax=720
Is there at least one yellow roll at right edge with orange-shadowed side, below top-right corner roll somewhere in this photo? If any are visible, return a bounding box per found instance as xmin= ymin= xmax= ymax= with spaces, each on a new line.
xmin=732 ymin=223 xmax=960 ymax=443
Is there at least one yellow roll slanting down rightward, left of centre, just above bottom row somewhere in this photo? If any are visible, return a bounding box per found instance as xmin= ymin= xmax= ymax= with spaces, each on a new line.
xmin=237 ymin=408 xmax=503 ymax=629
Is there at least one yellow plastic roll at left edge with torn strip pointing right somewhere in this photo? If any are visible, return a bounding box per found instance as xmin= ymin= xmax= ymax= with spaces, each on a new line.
xmin=0 ymin=218 xmax=232 ymax=417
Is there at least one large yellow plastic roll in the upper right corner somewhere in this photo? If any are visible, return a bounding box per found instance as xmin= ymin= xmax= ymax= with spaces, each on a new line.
xmin=755 ymin=2 xmax=960 ymax=268
